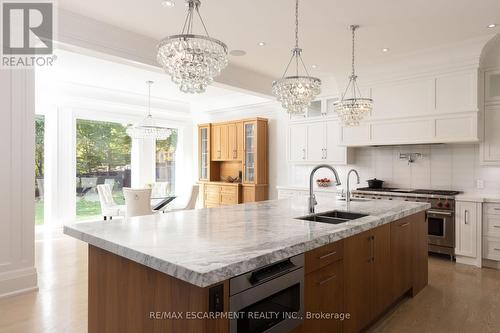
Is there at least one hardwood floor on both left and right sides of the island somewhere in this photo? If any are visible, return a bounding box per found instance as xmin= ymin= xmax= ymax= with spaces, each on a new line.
xmin=0 ymin=232 xmax=500 ymax=333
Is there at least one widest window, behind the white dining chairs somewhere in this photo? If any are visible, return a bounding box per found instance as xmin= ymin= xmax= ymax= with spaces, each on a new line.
xmin=76 ymin=119 xmax=132 ymax=220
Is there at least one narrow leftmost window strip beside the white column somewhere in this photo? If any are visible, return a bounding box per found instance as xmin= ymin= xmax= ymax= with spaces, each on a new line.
xmin=35 ymin=115 xmax=45 ymax=225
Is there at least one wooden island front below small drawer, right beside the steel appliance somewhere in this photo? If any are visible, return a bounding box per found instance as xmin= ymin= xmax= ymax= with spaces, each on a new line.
xmin=302 ymin=261 xmax=343 ymax=333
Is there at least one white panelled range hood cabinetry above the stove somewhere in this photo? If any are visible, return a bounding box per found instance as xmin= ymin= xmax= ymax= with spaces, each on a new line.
xmin=340 ymin=68 xmax=479 ymax=146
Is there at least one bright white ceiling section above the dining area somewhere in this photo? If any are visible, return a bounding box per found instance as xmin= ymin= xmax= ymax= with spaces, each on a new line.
xmin=37 ymin=50 xmax=268 ymax=111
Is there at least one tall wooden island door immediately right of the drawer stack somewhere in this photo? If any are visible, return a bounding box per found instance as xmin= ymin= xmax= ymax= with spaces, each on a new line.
xmin=343 ymin=231 xmax=374 ymax=333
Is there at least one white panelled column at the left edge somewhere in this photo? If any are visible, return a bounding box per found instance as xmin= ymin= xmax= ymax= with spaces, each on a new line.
xmin=0 ymin=69 xmax=37 ymax=297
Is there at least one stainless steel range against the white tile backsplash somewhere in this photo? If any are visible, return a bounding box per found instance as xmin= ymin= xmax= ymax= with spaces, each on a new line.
xmin=352 ymin=187 xmax=460 ymax=259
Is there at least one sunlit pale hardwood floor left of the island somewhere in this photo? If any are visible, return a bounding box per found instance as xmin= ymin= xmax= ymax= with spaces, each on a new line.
xmin=0 ymin=231 xmax=87 ymax=333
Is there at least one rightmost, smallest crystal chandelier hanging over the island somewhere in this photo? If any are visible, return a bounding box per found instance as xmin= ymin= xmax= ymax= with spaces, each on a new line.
xmin=333 ymin=25 xmax=373 ymax=126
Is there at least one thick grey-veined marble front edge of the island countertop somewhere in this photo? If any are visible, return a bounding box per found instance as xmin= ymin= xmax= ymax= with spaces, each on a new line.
xmin=63 ymin=203 xmax=431 ymax=288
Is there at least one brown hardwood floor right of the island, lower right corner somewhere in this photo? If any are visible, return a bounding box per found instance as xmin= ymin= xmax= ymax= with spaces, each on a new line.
xmin=370 ymin=257 xmax=500 ymax=333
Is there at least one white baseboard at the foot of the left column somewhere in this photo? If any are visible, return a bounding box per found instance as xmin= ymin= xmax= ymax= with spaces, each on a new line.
xmin=0 ymin=267 xmax=38 ymax=298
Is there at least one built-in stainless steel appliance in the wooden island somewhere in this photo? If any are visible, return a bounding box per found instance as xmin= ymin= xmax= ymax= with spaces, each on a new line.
xmin=229 ymin=254 xmax=304 ymax=333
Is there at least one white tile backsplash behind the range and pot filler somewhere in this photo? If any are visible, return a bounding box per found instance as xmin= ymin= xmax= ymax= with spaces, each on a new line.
xmin=289 ymin=144 xmax=500 ymax=190
